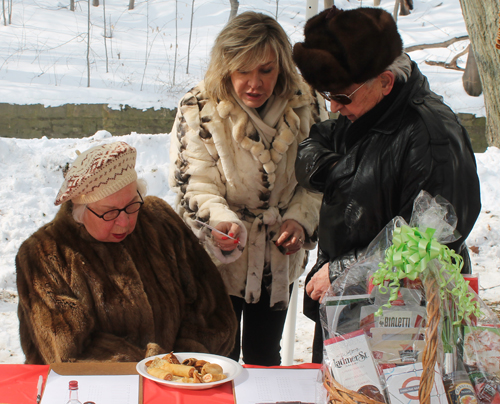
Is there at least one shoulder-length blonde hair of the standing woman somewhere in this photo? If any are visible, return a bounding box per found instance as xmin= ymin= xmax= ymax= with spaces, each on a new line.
xmin=205 ymin=11 xmax=300 ymax=100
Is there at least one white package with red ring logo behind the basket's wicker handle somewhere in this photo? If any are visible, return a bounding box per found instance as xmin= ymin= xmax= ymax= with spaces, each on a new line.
xmin=384 ymin=363 xmax=448 ymax=404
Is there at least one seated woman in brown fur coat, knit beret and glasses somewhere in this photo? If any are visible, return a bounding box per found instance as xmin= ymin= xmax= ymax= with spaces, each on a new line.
xmin=16 ymin=142 xmax=236 ymax=364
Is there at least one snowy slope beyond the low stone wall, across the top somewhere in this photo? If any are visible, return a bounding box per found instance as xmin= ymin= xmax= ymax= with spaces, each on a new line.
xmin=0 ymin=0 xmax=484 ymax=115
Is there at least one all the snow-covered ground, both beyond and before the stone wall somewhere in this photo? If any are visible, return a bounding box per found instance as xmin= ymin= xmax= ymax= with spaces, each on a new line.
xmin=0 ymin=0 xmax=500 ymax=363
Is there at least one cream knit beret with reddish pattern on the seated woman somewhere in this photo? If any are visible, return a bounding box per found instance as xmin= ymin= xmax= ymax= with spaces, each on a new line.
xmin=55 ymin=142 xmax=137 ymax=205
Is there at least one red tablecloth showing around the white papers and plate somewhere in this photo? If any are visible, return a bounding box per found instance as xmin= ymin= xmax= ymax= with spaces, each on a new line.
xmin=0 ymin=364 xmax=320 ymax=404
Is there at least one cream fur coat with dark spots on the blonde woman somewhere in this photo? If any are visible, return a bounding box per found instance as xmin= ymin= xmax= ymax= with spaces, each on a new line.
xmin=169 ymin=82 xmax=327 ymax=309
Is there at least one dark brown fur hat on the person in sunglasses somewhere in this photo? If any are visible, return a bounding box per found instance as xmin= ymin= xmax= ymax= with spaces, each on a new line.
xmin=293 ymin=6 xmax=403 ymax=92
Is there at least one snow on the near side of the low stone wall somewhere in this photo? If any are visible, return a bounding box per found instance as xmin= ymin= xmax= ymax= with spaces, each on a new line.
xmin=0 ymin=131 xmax=500 ymax=363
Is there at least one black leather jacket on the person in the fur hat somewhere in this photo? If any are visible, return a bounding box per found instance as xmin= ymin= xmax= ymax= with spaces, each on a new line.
xmin=295 ymin=63 xmax=481 ymax=318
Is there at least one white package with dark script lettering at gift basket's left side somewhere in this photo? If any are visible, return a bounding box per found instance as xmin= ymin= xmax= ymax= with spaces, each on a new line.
xmin=324 ymin=330 xmax=386 ymax=402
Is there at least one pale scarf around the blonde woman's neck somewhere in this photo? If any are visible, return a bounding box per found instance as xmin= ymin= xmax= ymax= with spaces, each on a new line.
xmin=232 ymin=89 xmax=288 ymax=149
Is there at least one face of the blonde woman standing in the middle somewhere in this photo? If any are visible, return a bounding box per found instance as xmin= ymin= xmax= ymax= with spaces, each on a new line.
xmin=231 ymin=50 xmax=280 ymax=108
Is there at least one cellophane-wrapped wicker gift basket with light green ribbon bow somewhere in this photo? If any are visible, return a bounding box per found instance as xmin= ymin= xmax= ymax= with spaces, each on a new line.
xmin=317 ymin=191 xmax=500 ymax=404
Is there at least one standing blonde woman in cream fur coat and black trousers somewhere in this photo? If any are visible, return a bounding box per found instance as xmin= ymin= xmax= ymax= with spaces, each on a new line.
xmin=170 ymin=12 xmax=326 ymax=365
